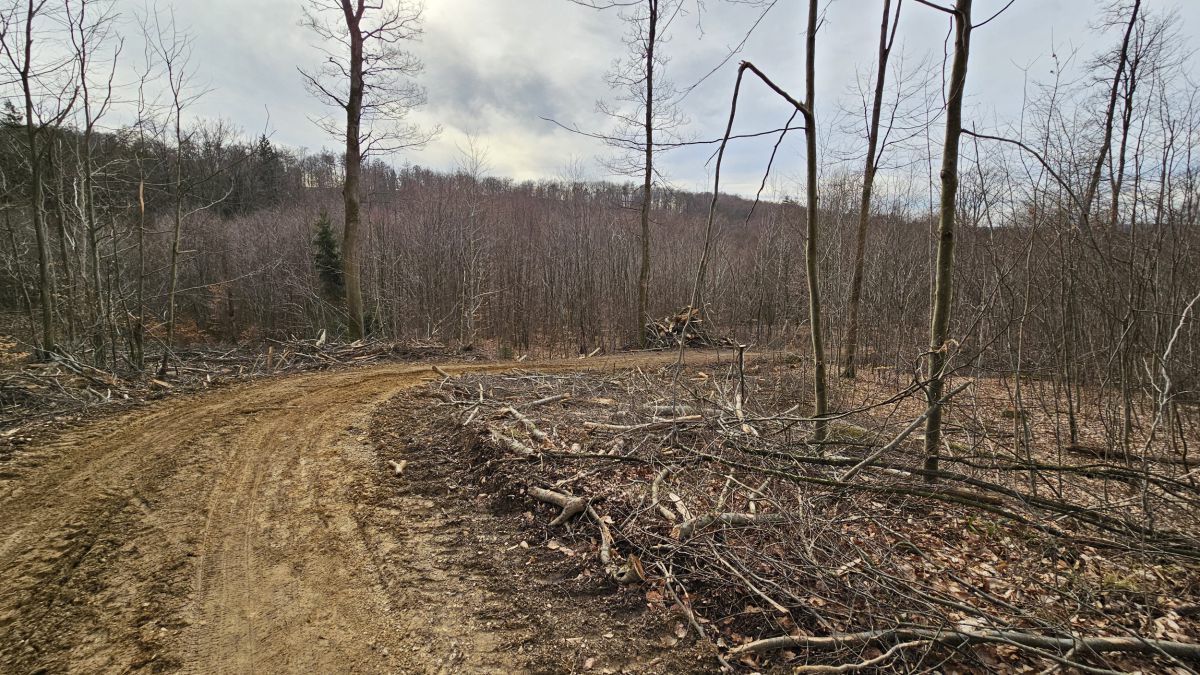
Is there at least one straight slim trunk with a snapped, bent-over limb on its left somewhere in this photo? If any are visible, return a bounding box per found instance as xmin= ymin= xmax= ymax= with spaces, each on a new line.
xmin=804 ymin=0 xmax=827 ymax=441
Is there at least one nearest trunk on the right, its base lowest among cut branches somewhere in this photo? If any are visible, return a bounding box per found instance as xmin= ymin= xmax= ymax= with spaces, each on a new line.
xmin=925 ymin=0 xmax=971 ymax=472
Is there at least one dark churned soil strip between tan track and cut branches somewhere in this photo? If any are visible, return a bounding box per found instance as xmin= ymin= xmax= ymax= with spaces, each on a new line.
xmin=362 ymin=390 xmax=718 ymax=673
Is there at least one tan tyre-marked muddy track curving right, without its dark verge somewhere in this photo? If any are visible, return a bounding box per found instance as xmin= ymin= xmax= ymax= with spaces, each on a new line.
xmin=0 ymin=354 xmax=710 ymax=673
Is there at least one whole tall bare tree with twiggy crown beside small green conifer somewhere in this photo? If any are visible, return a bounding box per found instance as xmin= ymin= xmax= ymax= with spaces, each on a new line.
xmin=300 ymin=0 xmax=437 ymax=339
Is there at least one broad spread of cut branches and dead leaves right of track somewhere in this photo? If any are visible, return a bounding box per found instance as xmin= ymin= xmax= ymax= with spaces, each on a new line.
xmin=415 ymin=355 xmax=1200 ymax=673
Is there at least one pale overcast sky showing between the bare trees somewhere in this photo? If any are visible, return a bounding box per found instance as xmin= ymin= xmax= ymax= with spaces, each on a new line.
xmin=131 ymin=0 xmax=1200 ymax=192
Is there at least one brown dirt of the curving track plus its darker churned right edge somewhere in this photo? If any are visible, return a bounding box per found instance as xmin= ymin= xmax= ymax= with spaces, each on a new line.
xmin=0 ymin=354 xmax=710 ymax=673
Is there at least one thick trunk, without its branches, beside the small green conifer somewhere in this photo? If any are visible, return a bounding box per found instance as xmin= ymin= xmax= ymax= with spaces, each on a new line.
xmin=342 ymin=0 xmax=366 ymax=340
